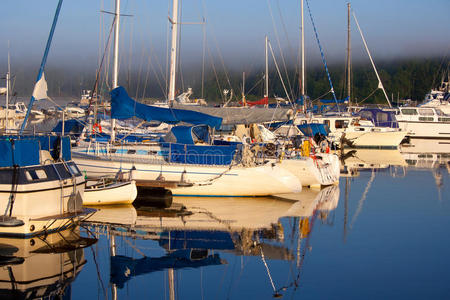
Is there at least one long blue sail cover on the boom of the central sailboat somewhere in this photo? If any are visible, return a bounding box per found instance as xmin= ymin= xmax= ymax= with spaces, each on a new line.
xmin=111 ymin=86 xmax=222 ymax=129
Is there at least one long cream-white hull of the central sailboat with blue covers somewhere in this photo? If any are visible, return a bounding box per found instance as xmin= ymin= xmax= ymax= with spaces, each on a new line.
xmin=73 ymin=155 xmax=301 ymax=196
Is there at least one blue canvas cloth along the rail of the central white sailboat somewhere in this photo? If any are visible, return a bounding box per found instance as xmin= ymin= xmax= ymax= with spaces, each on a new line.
xmin=169 ymin=143 xmax=238 ymax=165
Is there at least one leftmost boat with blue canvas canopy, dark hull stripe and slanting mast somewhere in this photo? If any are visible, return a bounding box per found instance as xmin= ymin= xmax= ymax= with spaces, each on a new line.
xmin=0 ymin=0 xmax=91 ymax=238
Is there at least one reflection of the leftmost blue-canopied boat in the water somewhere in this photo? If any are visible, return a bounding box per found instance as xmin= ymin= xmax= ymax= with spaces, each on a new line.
xmin=0 ymin=227 xmax=97 ymax=299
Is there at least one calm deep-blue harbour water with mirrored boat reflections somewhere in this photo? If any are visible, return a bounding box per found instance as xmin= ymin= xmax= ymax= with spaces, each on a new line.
xmin=0 ymin=147 xmax=450 ymax=299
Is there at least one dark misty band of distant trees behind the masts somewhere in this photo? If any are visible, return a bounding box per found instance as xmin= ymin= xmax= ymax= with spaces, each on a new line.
xmin=0 ymin=58 xmax=448 ymax=103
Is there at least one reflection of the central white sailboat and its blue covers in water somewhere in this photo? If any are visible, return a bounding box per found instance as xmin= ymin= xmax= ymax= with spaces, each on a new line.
xmin=84 ymin=186 xmax=339 ymax=299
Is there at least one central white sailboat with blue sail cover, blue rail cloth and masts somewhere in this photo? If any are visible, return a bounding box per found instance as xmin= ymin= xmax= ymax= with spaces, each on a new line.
xmin=73 ymin=0 xmax=301 ymax=196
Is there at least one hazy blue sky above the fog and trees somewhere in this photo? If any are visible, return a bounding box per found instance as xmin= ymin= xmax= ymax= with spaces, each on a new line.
xmin=0 ymin=0 xmax=450 ymax=73
